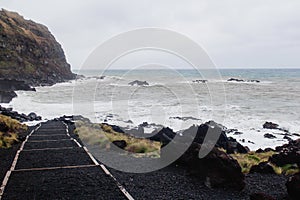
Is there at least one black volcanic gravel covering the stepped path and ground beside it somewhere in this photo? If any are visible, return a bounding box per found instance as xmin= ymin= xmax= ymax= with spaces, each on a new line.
xmin=0 ymin=121 xmax=287 ymax=200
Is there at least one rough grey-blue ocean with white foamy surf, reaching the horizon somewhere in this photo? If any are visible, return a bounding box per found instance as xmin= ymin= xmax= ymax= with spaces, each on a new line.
xmin=3 ymin=69 xmax=300 ymax=150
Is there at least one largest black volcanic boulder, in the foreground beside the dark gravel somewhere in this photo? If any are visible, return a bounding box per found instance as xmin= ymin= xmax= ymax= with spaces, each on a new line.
xmin=177 ymin=143 xmax=245 ymax=190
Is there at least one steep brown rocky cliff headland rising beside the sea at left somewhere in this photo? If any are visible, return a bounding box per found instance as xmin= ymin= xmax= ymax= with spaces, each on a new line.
xmin=0 ymin=9 xmax=75 ymax=86
